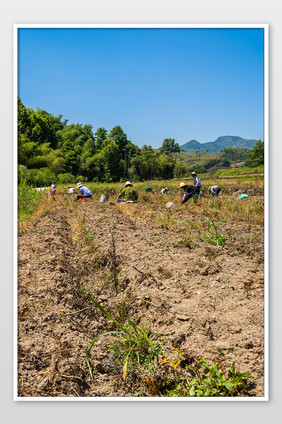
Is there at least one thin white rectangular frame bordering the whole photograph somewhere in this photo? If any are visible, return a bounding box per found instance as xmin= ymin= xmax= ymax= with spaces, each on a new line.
xmin=13 ymin=24 xmax=269 ymax=402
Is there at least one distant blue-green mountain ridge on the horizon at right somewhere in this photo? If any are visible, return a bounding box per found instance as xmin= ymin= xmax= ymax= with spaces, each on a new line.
xmin=180 ymin=135 xmax=258 ymax=153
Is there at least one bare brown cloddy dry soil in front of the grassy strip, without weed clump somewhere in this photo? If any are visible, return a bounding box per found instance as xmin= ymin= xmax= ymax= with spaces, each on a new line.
xmin=18 ymin=199 xmax=264 ymax=397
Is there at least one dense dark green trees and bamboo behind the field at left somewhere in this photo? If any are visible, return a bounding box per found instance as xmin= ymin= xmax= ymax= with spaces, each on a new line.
xmin=18 ymin=98 xmax=264 ymax=186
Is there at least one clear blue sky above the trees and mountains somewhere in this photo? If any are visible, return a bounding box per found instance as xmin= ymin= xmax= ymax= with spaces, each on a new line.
xmin=18 ymin=28 xmax=264 ymax=148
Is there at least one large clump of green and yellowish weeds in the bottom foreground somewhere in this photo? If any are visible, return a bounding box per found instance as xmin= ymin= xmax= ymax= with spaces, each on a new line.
xmin=86 ymin=294 xmax=252 ymax=397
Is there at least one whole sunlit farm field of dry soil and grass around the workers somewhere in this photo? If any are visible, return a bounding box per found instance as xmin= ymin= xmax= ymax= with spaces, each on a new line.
xmin=18 ymin=175 xmax=264 ymax=397
